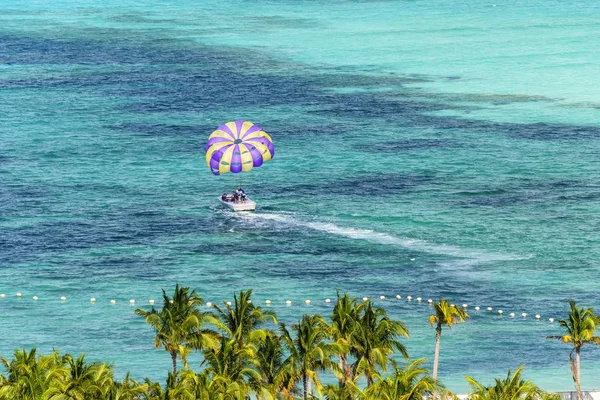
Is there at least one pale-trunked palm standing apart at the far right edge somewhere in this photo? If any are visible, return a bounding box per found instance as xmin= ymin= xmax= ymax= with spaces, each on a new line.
xmin=546 ymin=300 xmax=600 ymax=400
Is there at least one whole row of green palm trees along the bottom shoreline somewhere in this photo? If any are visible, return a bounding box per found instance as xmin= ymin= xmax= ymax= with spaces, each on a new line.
xmin=0 ymin=285 xmax=600 ymax=400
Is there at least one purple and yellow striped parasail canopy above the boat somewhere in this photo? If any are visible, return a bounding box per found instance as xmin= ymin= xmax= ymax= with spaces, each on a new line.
xmin=206 ymin=121 xmax=275 ymax=175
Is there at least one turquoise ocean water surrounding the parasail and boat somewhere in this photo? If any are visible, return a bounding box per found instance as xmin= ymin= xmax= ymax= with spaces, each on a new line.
xmin=0 ymin=0 xmax=600 ymax=392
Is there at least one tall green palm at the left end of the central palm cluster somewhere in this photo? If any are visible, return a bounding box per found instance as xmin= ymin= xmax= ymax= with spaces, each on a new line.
xmin=135 ymin=284 xmax=218 ymax=376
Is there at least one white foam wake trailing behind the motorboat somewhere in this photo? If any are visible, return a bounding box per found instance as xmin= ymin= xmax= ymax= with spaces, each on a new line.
xmin=241 ymin=213 xmax=533 ymax=264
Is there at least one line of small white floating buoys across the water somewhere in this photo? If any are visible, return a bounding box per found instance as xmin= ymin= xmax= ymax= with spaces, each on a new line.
xmin=0 ymin=292 xmax=555 ymax=323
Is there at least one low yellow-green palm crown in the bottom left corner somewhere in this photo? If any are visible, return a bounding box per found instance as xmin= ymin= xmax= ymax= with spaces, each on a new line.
xmin=0 ymin=348 xmax=68 ymax=400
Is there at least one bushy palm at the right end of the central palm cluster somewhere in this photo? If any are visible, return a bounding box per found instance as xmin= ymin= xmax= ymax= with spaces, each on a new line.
xmin=351 ymin=301 xmax=409 ymax=387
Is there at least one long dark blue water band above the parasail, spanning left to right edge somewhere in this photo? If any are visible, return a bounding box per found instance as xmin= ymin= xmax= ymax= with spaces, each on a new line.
xmin=0 ymin=35 xmax=600 ymax=140
